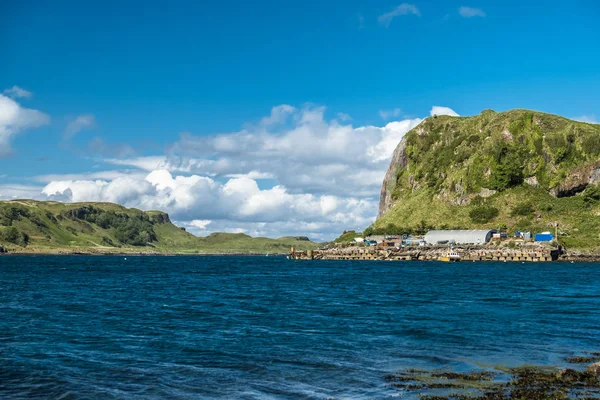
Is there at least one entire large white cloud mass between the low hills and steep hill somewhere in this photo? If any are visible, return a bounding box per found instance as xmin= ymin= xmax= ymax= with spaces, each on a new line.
xmin=29 ymin=105 xmax=458 ymax=240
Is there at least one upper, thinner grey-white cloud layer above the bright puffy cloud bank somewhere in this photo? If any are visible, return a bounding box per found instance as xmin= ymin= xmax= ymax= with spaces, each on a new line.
xmin=157 ymin=106 xmax=421 ymax=196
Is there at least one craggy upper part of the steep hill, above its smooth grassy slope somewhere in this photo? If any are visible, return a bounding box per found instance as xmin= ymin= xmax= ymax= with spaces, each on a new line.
xmin=378 ymin=110 xmax=600 ymax=218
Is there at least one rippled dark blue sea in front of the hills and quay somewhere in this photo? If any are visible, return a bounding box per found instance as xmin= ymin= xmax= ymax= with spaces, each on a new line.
xmin=0 ymin=256 xmax=600 ymax=399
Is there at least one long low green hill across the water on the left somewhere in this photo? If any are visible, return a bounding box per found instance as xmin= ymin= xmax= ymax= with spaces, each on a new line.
xmin=0 ymin=200 xmax=318 ymax=254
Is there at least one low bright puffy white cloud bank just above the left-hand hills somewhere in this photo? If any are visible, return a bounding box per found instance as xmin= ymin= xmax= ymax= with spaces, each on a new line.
xmin=42 ymin=170 xmax=377 ymax=238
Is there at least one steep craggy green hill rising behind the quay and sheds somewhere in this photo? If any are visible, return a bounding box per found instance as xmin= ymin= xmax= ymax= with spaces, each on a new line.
xmin=366 ymin=110 xmax=600 ymax=249
